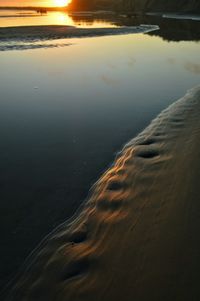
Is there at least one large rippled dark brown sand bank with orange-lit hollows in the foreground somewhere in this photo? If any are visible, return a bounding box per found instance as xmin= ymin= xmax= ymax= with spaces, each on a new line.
xmin=6 ymin=87 xmax=200 ymax=301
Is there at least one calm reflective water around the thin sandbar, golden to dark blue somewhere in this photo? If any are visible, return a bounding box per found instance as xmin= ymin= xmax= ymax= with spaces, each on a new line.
xmin=0 ymin=11 xmax=200 ymax=286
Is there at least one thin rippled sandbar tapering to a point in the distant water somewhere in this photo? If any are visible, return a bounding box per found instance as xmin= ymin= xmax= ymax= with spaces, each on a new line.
xmin=0 ymin=25 xmax=159 ymax=52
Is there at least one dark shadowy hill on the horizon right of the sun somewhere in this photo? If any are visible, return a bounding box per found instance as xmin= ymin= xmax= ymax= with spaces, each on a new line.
xmin=69 ymin=0 xmax=200 ymax=13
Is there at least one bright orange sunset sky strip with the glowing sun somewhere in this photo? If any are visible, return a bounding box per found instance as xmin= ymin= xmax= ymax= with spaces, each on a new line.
xmin=0 ymin=0 xmax=70 ymax=6
